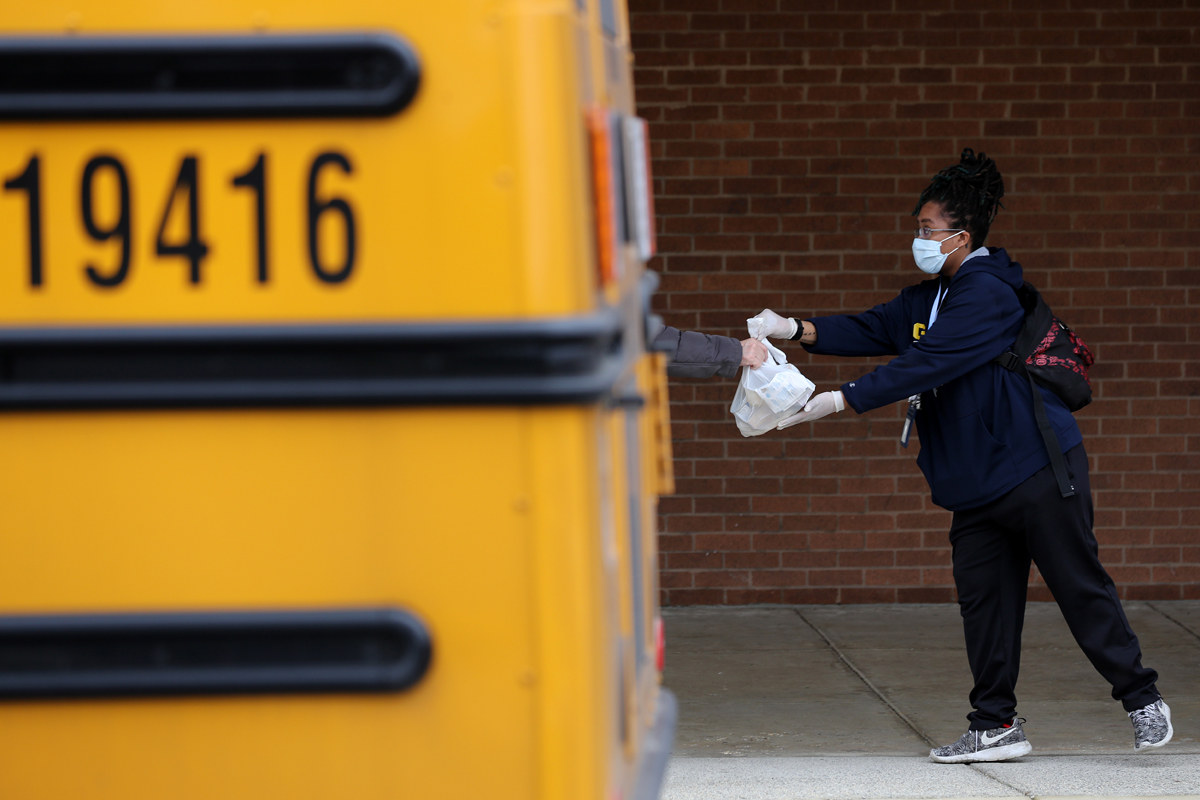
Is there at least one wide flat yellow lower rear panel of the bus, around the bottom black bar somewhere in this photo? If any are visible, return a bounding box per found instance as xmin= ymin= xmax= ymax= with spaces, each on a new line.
xmin=0 ymin=409 xmax=535 ymax=800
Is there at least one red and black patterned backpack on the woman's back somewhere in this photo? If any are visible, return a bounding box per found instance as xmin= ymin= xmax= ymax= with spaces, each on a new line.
xmin=995 ymin=282 xmax=1096 ymax=498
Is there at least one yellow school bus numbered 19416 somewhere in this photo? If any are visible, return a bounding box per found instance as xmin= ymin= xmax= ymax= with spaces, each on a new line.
xmin=0 ymin=0 xmax=676 ymax=800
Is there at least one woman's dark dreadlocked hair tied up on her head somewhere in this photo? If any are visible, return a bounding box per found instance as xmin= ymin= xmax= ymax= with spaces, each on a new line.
xmin=912 ymin=148 xmax=1004 ymax=247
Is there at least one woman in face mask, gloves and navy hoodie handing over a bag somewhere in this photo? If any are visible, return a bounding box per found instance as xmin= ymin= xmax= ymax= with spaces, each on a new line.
xmin=761 ymin=149 xmax=1172 ymax=763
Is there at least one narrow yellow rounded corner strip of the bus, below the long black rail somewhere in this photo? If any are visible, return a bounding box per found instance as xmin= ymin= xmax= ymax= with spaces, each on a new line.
xmin=529 ymin=407 xmax=619 ymax=800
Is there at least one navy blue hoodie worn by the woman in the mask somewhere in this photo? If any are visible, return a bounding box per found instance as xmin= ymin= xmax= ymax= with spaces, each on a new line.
xmin=805 ymin=248 xmax=1082 ymax=511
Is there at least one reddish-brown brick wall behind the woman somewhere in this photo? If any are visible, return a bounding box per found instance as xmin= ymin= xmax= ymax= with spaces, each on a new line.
xmin=630 ymin=0 xmax=1200 ymax=604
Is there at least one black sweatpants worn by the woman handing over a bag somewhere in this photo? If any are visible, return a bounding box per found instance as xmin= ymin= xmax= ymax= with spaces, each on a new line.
xmin=950 ymin=445 xmax=1158 ymax=730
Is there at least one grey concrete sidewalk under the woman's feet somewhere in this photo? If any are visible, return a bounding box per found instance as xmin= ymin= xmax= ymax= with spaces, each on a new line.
xmin=664 ymin=601 xmax=1200 ymax=800
